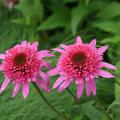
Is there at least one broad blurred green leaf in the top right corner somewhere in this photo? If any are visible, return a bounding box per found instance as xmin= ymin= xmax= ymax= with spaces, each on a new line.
xmin=97 ymin=2 xmax=120 ymax=20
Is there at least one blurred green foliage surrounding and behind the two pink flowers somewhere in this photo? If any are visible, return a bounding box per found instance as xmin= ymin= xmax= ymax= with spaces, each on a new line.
xmin=0 ymin=0 xmax=120 ymax=120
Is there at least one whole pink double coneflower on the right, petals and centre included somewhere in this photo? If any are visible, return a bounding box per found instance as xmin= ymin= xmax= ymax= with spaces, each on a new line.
xmin=48 ymin=36 xmax=116 ymax=98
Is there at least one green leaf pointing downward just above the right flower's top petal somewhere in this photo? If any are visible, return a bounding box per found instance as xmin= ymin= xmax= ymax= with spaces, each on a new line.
xmin=71 ymin=5 xmax=89 ymax=35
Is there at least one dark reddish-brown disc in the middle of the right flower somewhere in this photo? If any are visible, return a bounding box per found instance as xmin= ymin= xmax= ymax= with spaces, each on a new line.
xmin=72 ymin=52 xmax=87 ymax=64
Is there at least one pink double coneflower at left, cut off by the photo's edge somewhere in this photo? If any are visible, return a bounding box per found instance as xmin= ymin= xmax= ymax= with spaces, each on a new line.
xmin=0 ymin=41 xmax=54 ymax=98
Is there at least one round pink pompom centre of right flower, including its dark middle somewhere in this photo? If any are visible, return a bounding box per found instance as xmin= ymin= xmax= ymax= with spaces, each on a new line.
xmin=58 ymin=44 xmax=101 ymax=78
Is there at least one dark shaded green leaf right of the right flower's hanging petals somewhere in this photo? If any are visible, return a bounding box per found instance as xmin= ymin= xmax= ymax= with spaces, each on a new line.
xmin=96 ymin=78 xmax=115 ymax=108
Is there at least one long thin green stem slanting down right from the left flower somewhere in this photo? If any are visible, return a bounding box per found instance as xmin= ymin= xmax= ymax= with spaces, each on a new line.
xmin=32 ymin=83 xmax=68 ymax=120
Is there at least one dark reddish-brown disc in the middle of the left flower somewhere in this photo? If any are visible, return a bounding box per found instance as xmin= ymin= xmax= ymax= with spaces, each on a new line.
xmin=13 ymin=53 xmax=27 ymax=66
